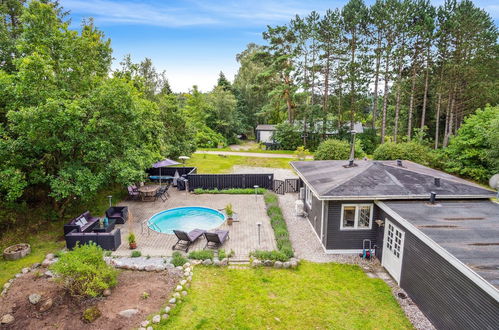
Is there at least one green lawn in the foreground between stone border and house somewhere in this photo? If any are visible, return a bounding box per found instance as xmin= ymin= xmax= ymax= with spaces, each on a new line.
xmin=158 ymin=262 xmax=412 ymax=329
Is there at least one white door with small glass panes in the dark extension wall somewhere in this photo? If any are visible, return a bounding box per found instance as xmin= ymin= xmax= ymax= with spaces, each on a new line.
xmin=382 ymin=219 xmax=405 ymax=283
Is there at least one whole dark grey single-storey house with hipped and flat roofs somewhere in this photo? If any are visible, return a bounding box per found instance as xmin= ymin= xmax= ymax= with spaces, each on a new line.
xmin=292 ymin=160 xmax=499 ymax=329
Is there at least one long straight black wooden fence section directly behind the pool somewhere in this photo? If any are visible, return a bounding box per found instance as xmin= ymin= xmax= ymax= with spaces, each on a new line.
xmin=187 ymin=174 xmax=274 ymax=191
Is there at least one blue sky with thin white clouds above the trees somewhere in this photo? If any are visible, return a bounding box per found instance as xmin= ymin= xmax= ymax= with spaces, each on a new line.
xmin=60 ymin=0 xmax=499 ymax=92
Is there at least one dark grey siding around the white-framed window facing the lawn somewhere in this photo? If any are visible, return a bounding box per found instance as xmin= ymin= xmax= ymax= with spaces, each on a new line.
xmin=326 ymin=201 xmax=379 ymax=250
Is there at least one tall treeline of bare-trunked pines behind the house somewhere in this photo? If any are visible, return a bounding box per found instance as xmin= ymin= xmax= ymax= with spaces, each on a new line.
xmin=234 ymin=0 xmax=499 ymax=148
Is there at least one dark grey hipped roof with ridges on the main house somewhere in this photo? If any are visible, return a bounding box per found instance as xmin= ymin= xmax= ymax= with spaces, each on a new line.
xmin=291 ymin=160 xmax=495 ymax=200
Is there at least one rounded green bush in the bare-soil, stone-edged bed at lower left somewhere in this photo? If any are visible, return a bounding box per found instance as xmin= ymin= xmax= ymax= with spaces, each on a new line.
xmin=51 ymin=243 xmax=117 ymax=297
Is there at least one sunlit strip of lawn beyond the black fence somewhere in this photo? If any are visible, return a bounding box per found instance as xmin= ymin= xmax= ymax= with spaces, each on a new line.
xmin=185 ymin=154 xmax=292 ymax=174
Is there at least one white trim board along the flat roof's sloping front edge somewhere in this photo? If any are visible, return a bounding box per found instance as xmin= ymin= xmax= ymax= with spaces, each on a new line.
xmin=374 ymin=201 xmax=499 ymax=302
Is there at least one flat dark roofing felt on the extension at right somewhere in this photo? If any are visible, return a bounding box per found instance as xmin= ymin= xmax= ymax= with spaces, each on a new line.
xmin=384 ymin=200 xmax=499 ymax=288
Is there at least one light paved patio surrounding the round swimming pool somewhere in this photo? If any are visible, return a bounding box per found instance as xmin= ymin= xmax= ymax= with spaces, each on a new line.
xmin=113 ymin=188 xmax=276 ymax=260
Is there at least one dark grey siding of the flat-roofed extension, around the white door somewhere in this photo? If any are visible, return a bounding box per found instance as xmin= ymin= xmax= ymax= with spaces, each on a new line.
xmin=379 ymin=210 xmax=499 ymax=329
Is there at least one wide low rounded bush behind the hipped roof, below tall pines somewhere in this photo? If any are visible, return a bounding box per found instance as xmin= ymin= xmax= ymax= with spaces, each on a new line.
xmin=373 ymin=142 xmax=433 ymax=166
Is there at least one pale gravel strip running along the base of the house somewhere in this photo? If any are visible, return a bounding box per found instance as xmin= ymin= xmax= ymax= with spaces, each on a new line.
xmin=278 ymin=194 xmax=435 ymax=330
